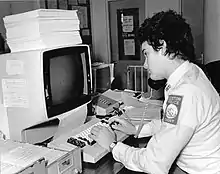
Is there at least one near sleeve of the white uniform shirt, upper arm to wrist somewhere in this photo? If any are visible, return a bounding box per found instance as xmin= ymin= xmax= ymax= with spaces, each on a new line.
xmin=112 ymin=86 xmax=198 ymax=174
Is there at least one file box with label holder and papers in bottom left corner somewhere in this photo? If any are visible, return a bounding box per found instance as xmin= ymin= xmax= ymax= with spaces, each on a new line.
xmin=0 ymin=140 xmax=82 ymax=174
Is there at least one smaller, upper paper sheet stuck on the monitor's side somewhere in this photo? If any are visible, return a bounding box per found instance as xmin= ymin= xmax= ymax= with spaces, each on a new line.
xmin=6 ymin=60 xmax=24 ymax=75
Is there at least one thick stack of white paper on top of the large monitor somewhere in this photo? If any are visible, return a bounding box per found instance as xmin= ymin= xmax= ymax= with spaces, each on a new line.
xmin=3 ymin=9 xmax=82 ymax=52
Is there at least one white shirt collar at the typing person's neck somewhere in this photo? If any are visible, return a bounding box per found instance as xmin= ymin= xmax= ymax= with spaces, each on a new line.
xmin=165 ymin=61 xmax=190 ymax=91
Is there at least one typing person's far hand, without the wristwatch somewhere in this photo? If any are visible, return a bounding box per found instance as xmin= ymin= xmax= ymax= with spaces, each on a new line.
xmin=109 ymin=116 xmax=137 ymax=135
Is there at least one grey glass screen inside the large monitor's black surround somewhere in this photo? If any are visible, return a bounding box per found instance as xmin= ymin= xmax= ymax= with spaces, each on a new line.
xmin=49 ymin=53 xmax=84 ymax=106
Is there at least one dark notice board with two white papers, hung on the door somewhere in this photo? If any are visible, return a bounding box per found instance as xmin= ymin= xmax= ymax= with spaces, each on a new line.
xmin=117 ymin=8 xmax=140 ymax=60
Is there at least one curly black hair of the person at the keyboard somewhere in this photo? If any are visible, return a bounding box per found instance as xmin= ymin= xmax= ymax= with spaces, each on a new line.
xmin=138 ymin=10 xmax=195 ymax=61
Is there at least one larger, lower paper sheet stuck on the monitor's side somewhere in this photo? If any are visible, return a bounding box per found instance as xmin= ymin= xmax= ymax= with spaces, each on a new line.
xmin=2 ymin=79 xmax=29 ymax=108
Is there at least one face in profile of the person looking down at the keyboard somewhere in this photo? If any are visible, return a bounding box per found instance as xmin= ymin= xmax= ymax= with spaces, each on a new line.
xmin=141 ymin=42 xmax=164 ymax=80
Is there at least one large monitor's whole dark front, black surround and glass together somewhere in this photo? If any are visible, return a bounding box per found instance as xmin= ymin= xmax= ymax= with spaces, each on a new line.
xmin=43 ymin=46 xmax=91 ymax=118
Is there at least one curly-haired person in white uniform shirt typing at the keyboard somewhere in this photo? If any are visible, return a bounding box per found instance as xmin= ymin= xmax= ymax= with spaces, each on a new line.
xmin=91 ymin=10 xmax=220 ymax=174
